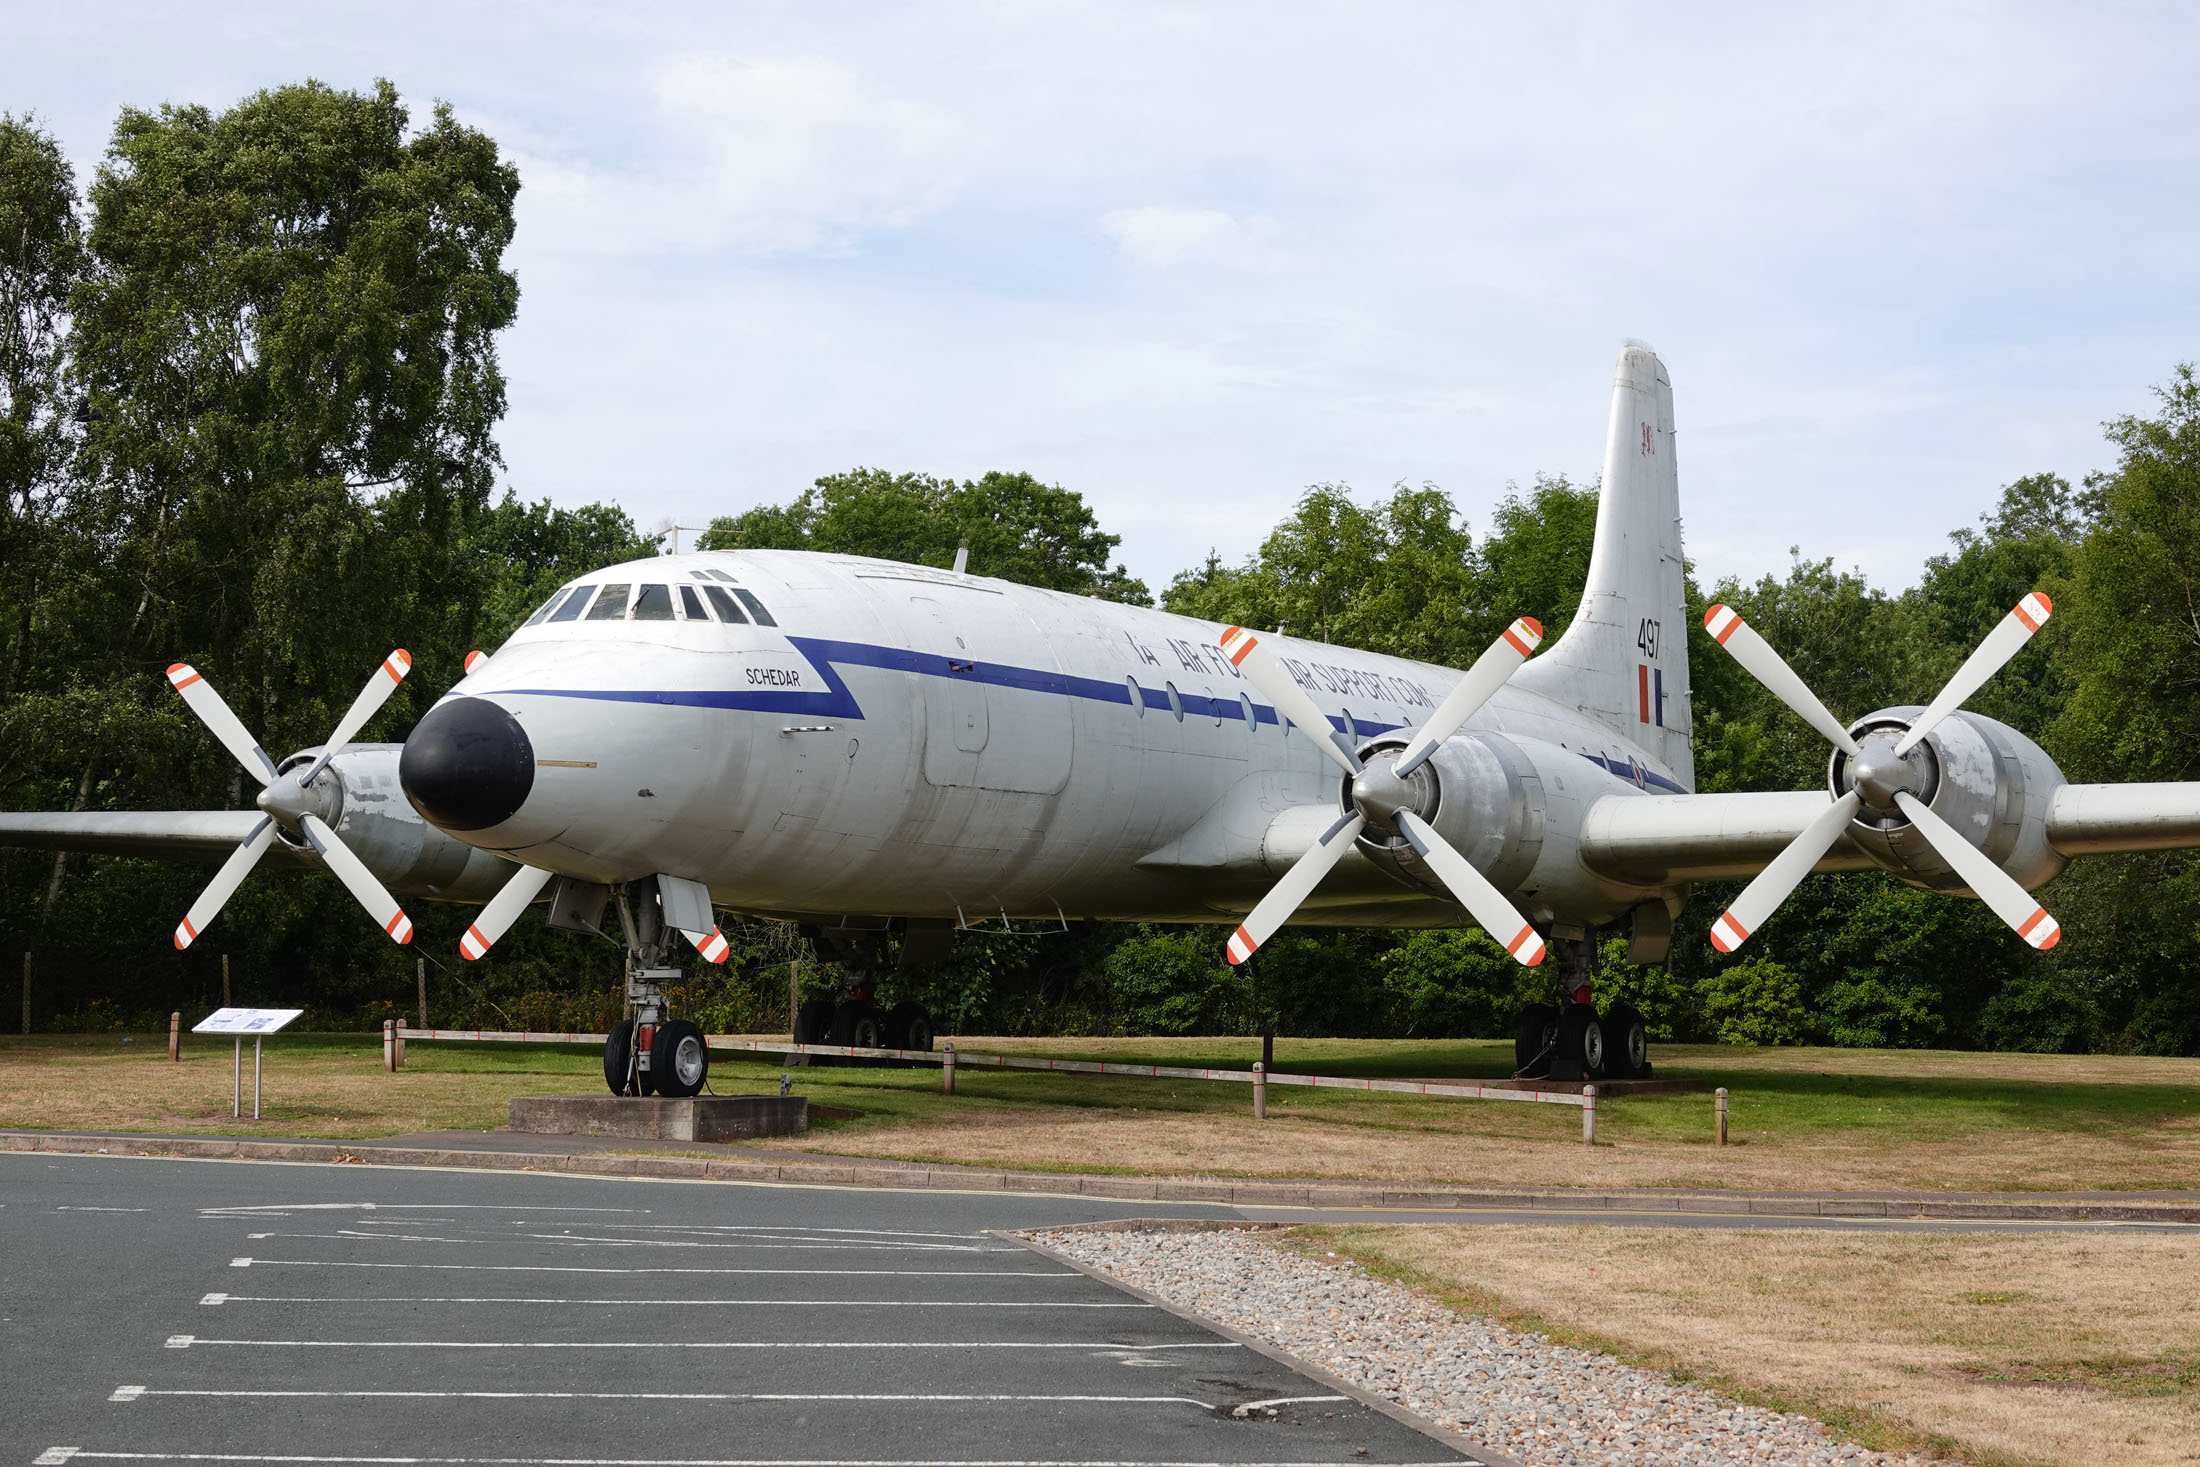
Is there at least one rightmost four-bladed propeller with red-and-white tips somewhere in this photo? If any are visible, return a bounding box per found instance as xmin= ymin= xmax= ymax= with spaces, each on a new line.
xmin=1703 ymin=592 xmax=2061 ymax=952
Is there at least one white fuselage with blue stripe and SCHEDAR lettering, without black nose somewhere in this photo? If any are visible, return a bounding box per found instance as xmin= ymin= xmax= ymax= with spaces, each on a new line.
xmin=451 ymin=550 xmax=1681 ymax=926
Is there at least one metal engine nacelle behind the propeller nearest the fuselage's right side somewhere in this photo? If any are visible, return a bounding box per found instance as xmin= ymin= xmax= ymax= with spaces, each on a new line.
xmin=1342 ymin=732 xmax=1544 ymax=897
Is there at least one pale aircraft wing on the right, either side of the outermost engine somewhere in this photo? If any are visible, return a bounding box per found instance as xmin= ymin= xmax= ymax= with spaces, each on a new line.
xmin=1582 ymin=783 xmax=2200 ymax=886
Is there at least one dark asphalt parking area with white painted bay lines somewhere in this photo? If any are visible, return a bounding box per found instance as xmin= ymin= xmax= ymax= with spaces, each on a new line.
xmin=0 ymin=1152 xmax=1487 ymax=1467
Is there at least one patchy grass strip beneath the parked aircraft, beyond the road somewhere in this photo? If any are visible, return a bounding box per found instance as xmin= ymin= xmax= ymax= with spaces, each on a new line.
xmin=0 ymin=1034 xmax=2200 ymax=1192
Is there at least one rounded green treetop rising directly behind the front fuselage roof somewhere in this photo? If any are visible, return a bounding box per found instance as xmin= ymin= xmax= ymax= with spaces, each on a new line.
xmin=697 ymin=468 xmax=1153 ymax=605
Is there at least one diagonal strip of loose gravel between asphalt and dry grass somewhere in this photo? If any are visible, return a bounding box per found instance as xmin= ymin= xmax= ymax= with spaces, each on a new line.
xmin=1023 ymin=1232 xmax=1929 ymax=1467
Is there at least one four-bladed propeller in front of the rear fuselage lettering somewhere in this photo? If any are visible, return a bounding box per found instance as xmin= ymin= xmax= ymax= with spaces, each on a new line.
xmin=1221 ymin=616 xmax=1544 ymax=968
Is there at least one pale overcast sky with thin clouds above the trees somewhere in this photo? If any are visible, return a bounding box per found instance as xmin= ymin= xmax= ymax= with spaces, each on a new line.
xmin=0 ymin=0 xmax=2200 ymax=589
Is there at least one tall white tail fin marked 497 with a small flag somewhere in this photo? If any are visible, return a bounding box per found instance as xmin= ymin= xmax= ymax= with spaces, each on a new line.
xmin=1514 ymin=343 xmax=1696 ymax=790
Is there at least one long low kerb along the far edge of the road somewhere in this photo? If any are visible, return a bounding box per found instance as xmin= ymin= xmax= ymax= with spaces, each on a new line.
xmin=0 ymin=1130 xmax=2200 ymax=1223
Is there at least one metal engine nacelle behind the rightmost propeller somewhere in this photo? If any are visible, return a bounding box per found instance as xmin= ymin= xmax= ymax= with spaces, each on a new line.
xmin=1826 ymin=706 xmax=2064 ymax=891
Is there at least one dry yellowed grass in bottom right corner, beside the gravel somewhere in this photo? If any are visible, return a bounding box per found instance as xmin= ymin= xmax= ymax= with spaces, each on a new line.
xmin=1300 ymin=1225 xmax=2200 ymax=1467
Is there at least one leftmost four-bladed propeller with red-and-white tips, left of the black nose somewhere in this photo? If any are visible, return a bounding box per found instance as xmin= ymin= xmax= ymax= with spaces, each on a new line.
xmin=167 ymin=647 xmax=411 ymax=948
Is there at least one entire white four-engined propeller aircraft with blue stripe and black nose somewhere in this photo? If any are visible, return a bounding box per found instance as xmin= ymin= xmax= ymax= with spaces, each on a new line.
xmin=0 ymin=345 xmax=2200 ymax=1095
